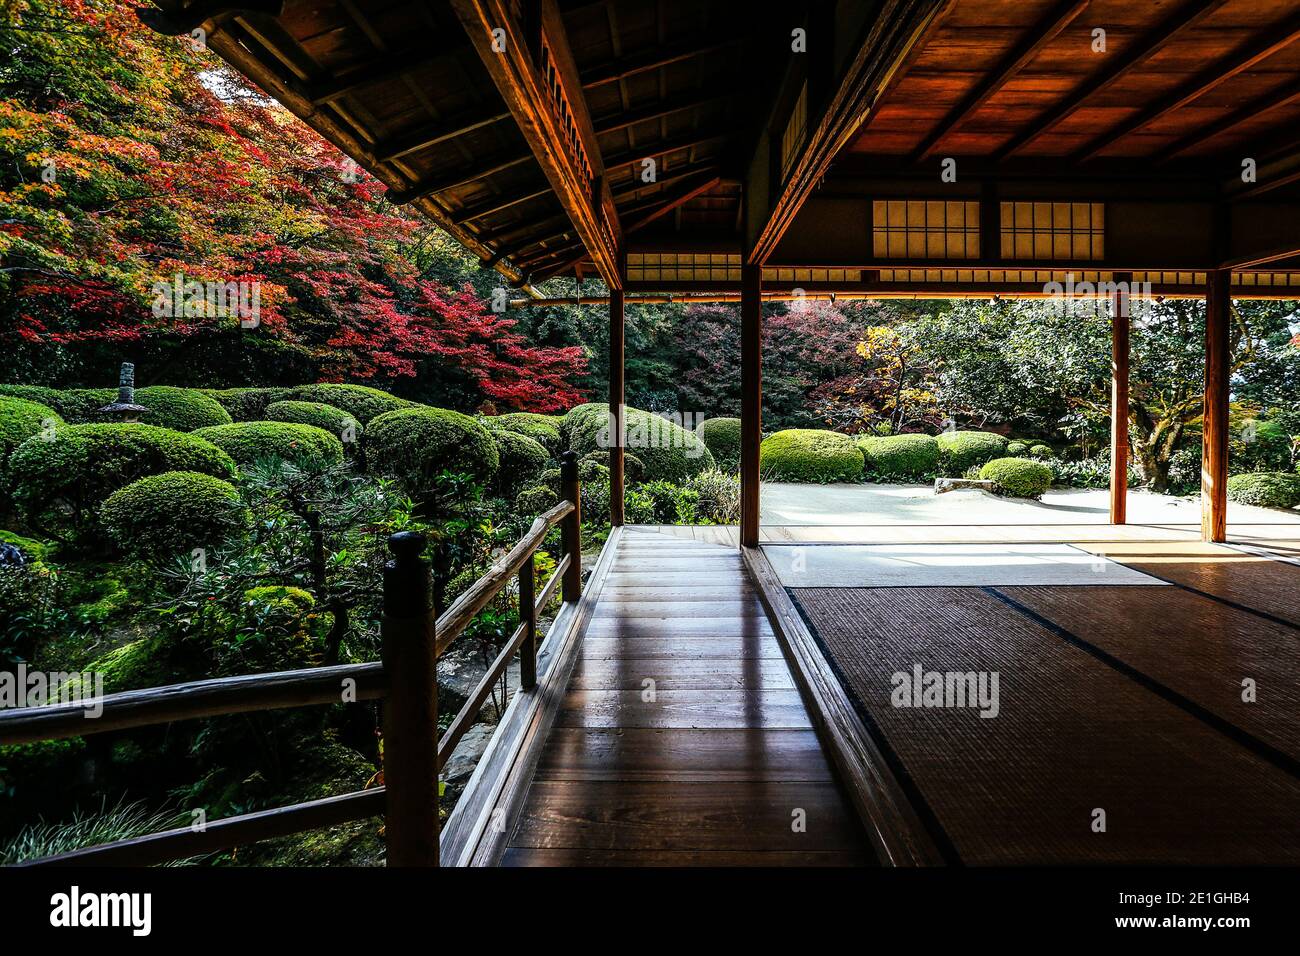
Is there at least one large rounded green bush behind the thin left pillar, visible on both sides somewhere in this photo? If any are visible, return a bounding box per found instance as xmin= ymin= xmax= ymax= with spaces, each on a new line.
xmin=562 ymin=403 xmax=715 ymax=484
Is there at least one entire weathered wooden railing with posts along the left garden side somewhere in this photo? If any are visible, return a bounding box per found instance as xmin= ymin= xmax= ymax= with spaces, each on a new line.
xmin=0 ymin=451 xmax=582 ymax=866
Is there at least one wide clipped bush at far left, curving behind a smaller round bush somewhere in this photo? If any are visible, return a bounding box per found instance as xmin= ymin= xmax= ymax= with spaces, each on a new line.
xmin=8 ymin=423 xmax=235 ymax=538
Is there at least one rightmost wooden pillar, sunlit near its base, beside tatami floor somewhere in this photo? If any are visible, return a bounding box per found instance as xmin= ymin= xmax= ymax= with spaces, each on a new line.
xmin=1201 ymin=269 xmax=1232 ymax=541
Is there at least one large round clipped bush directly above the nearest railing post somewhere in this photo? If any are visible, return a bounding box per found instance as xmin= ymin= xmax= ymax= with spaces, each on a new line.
xmin=365 ymin=406 xmax=501 ymax=494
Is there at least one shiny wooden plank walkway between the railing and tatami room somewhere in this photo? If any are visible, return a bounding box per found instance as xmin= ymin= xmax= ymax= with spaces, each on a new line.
xmin=502 ymin=528 xmax=874 ymax=866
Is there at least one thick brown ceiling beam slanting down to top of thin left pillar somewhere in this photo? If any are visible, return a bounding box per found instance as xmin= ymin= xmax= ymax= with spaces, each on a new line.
xmin=451 ymin=0 xmax=623 ymax=289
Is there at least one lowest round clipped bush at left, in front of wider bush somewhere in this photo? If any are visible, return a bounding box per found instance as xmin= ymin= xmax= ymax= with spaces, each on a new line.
xmin=100 ymin=471 xmax=244 ymax=557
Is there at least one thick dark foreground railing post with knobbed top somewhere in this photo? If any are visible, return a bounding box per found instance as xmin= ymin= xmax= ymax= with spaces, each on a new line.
xmin=381 ymin=531 xmax=438 ymax=866
